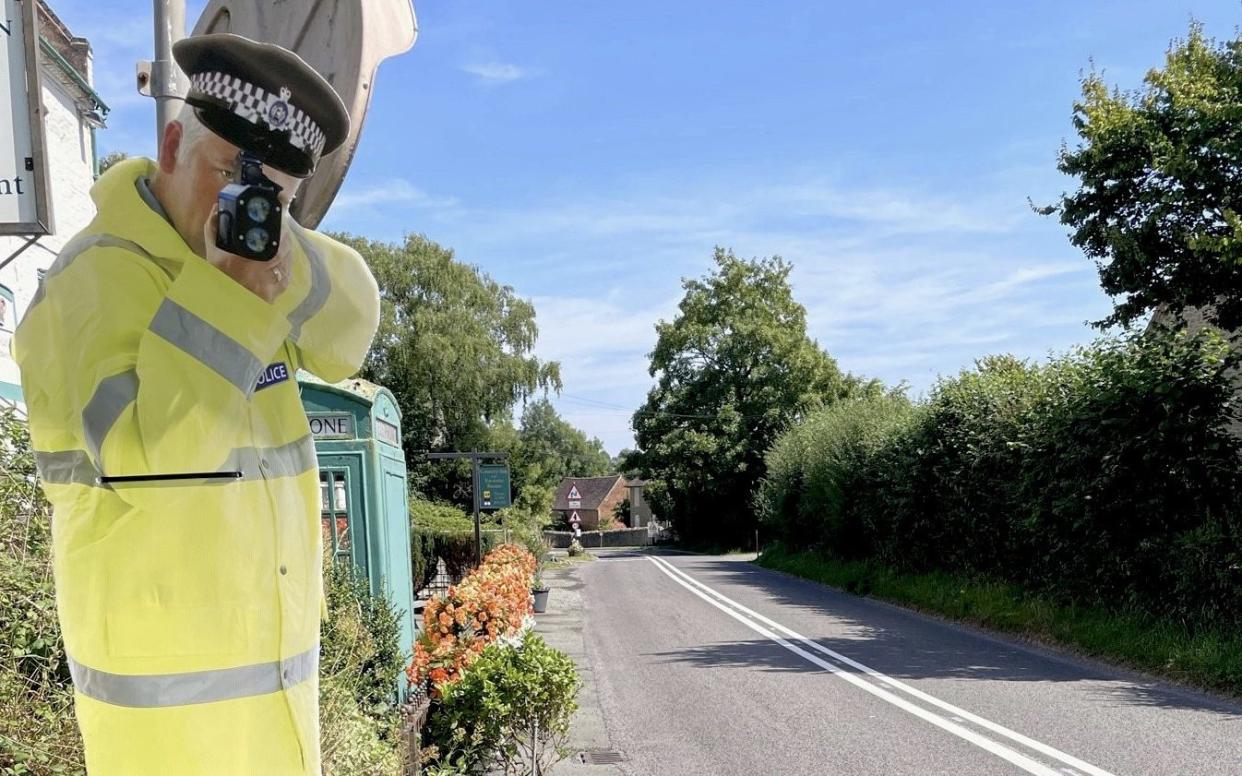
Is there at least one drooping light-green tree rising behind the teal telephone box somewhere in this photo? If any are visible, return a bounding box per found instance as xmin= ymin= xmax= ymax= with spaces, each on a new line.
xmin=335 ymin=235 xmax=561 ymax=504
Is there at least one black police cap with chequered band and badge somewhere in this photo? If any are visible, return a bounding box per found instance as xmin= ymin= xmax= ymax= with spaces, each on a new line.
xmin=173 ymin=32 xmax=349 ymax=178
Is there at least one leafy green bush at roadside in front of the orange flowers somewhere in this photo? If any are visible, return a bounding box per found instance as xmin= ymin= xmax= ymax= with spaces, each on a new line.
xmin=424 ymin=632 xmax=580 ymax=774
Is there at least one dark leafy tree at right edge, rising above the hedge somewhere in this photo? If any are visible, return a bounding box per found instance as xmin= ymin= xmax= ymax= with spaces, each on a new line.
xmin=1041 ymin=22 xmax=1242 ymax=329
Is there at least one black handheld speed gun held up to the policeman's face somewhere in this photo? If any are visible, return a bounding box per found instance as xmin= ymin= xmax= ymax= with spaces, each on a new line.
xmin=216 ymin=150 xmax=281 ymax=262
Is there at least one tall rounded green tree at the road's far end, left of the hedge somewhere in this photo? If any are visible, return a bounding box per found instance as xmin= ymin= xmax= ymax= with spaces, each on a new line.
xmin=627 ymin=248 xmax=861 ymax=545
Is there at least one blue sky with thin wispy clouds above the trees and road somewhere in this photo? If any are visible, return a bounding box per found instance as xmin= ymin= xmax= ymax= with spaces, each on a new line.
xmin=45 ymin=0 xmax=1242 ymax=453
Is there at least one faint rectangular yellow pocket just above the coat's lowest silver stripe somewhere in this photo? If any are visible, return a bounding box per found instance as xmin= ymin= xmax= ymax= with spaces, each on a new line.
xmin=107 ymin=606 xmax=253 ymax=658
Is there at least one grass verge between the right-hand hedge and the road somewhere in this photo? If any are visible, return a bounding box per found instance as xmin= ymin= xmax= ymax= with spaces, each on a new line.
xmin=756 ymin=546 xmax=1242 ymax=698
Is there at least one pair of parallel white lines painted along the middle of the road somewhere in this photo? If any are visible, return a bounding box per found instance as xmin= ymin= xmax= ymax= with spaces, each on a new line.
xmin=648 ymin=556 xmax=1114 ymax=776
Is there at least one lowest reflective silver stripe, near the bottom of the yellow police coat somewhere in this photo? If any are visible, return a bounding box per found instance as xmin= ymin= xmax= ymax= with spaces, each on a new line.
xmin=68 ymin=644 xmax=319 ymax=709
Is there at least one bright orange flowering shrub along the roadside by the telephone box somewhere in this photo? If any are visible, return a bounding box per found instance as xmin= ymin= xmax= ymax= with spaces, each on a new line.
xmin=406 ymin=544 xmax=535 ymax=698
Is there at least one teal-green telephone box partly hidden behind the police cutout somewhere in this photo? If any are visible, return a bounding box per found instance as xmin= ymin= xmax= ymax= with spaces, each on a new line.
xmin=298 ymin=371 xmax=415 ymax=688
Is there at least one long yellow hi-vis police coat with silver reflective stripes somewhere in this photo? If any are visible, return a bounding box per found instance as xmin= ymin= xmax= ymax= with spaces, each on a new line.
xmin=12 ymin=159 xmax=379 ymax=776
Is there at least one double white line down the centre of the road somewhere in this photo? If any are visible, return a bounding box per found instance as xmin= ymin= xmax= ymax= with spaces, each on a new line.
xmin=647 ymin=555 xmax=1113 ymax=776
